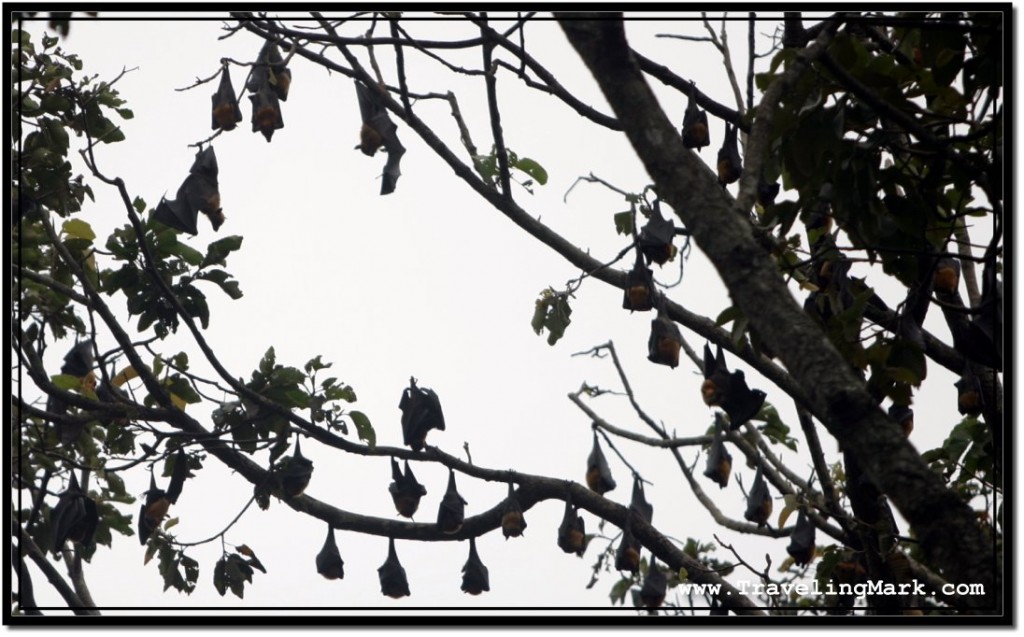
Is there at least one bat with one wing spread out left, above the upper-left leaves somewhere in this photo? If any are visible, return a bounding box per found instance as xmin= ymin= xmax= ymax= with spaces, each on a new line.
xmin=153 ymin=146 xmax=224 ymax=235
